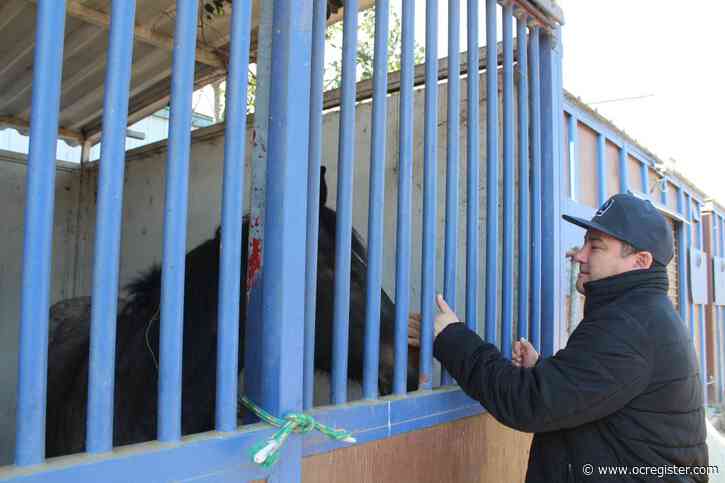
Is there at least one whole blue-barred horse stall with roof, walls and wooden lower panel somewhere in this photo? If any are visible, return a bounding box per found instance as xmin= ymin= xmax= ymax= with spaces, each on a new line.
xmin=0 ymin=0 xmax=564 ymax=481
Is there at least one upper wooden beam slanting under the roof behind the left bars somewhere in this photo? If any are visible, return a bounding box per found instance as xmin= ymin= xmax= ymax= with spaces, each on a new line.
xmin=30 ymin=0 xmax=225 ymax=69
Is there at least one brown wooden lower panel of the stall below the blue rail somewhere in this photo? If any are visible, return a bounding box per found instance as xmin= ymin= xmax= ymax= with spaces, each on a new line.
xmin=302 ymin=414 xmax=531 ymax=483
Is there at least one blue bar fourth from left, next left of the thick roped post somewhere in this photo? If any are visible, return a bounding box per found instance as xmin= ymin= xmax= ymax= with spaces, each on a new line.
xmin=215 ymin=0 xmax=252 ymax=431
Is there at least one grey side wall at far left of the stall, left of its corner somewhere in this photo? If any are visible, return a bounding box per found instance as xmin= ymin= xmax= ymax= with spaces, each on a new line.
xmin=0 ymin=151 xmax=79 ymax=464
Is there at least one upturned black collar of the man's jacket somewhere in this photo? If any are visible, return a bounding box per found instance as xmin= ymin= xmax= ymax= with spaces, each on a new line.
xmin=584 ymin=266 xmax=669 ymax=318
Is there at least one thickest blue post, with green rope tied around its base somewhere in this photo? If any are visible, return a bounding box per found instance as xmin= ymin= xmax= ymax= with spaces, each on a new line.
xmin=260 ymin=0 xmax=310 ymax=482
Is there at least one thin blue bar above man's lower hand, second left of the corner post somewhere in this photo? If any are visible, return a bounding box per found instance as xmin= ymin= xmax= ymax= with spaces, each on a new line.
xmin=516 ymin=12 xmax=531 ymax=338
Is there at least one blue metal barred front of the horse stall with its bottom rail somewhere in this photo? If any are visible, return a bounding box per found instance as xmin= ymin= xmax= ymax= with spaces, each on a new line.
xmin=0 ymin=0 xmax=563 ymax=481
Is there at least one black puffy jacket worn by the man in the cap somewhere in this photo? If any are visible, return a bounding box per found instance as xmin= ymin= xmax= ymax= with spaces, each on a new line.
xmin=434 ymin=267 xmax=708 ymax=483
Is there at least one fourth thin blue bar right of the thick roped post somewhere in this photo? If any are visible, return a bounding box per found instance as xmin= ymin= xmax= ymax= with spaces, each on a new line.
xmin=393 ymin=0 xmax=415 ymax=395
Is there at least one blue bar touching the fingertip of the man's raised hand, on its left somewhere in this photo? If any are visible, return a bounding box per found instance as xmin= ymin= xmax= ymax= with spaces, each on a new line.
xmin=419 ymin=0 xmax=438 ymax=389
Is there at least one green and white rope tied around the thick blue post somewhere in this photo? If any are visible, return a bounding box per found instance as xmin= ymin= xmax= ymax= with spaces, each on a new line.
xmin=242 ymin=397 xmax=356 ymax=468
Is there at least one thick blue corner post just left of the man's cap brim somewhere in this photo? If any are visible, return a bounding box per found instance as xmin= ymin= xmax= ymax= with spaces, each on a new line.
xmin=541 ymin=28 xmax=563 ymax=357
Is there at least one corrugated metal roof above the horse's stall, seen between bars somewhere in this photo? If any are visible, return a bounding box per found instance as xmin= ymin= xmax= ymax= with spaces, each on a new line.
xmin=0 ymin=0 xmax=373 ymax=147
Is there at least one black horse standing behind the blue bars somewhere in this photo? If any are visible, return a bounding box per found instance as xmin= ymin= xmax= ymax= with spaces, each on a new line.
xmin=46 ymin=168 xmax=418 ymax=457
